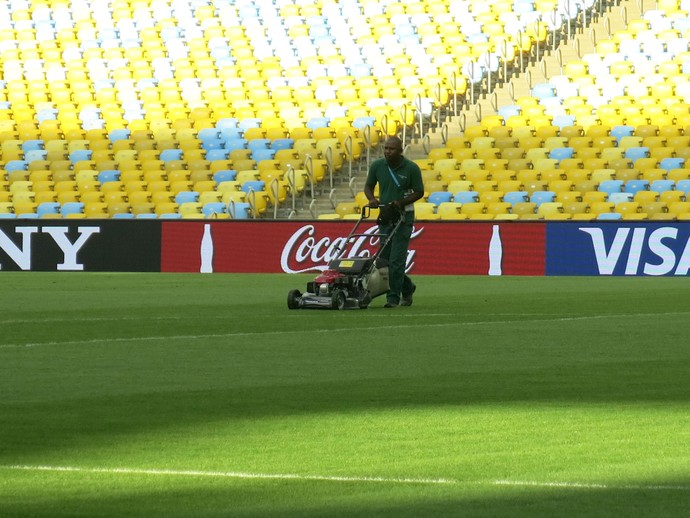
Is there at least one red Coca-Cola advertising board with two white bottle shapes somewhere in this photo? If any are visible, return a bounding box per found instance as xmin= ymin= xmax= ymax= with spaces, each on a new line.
xmin=161 ymin=221 xmax=546 ymax=275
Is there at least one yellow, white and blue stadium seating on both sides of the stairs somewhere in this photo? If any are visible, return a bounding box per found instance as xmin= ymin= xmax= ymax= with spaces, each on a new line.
xmin=0 ymin=0 xmax=690 ymax=220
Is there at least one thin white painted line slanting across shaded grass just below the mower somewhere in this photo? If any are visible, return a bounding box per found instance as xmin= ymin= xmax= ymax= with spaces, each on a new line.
xmin=0 ymin=311 xmax=690 ymax=349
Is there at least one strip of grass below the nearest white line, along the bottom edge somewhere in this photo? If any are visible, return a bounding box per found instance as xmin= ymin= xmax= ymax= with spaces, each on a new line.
xmin=0 ymin=478 xmax=690 ymax=518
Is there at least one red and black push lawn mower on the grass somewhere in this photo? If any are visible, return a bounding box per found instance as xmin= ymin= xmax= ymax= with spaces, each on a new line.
xmin=287 ymin=204 xmax=403 ymax=309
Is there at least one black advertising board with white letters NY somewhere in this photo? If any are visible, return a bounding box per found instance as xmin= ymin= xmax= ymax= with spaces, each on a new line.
xmin=0 ymin=219 xmax=161 ymax=272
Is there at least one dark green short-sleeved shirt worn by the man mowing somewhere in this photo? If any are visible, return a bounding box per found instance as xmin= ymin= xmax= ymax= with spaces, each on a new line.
xmin=366 ymin=157 xmax=424 ymax=221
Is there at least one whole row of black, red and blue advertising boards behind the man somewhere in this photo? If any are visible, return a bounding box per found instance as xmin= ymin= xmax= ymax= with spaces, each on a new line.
xmin=0 ymin=220 xmax=690 ymax=276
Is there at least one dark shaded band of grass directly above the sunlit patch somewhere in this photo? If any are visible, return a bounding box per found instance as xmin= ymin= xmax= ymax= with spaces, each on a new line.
xmin=0 ymin=356 xmax=690 ymax=464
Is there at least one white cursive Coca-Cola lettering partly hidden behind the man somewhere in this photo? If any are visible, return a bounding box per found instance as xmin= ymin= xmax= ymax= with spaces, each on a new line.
xmin=280 ymin=225 xmax=423 ymax=273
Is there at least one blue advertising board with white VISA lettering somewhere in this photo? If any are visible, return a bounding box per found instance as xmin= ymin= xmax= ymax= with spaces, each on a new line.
xmin=546 ymin=221 xmax=690 ymax=276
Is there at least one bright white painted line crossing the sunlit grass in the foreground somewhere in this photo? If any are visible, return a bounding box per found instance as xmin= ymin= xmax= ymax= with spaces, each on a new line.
xmin=0 ymin=465 xmax=690 ymax=491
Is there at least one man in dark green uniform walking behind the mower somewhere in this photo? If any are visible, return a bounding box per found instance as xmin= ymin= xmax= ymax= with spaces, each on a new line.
xmin=364 ymin=137 xmax=424 ymax=308
